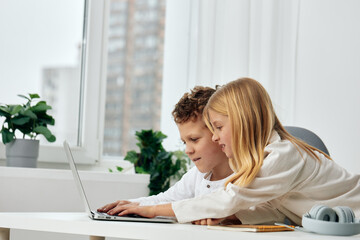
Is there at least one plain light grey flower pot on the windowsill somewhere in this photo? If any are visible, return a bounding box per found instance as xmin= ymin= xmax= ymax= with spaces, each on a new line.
xmin=6 ymin=139 xmax=39 ymax=168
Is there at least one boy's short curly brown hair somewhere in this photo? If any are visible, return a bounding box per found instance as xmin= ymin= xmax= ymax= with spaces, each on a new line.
xmin=172 ymin=86 xmax=216 ymax=124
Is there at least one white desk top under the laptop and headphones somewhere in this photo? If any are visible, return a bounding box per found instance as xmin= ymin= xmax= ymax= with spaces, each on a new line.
xmin=0 ymin=212 xmax=360 ymax=240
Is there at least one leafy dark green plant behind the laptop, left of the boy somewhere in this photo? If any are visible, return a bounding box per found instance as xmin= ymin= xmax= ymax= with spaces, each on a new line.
xmin=124 ymin=130 xmax=190 ymax=195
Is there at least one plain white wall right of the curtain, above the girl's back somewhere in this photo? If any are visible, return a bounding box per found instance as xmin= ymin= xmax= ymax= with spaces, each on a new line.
xmin=294 ymin=0 xmax=360 ymax=173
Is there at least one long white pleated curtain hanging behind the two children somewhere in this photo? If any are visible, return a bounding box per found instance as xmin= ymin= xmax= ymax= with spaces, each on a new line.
xmin=162 ymin=0 xmax=300 ymax=150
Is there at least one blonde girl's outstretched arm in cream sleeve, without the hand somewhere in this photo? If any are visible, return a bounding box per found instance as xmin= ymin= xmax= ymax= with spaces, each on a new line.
xmin=172 ymin=137 xmax=310 ymax=223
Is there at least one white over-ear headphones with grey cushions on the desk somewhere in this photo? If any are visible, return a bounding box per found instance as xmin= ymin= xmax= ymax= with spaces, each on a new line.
xmin=302 ymin=205 xmax=360 ymax=236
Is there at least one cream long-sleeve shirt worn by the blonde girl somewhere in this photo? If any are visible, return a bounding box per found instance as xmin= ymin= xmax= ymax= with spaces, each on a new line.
xmin=172 ymin=131 xmax=360 ymax=225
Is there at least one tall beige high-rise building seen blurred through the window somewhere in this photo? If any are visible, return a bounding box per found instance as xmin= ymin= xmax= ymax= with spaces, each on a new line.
xmin=103 ymin=0 xmax=170 ymax=156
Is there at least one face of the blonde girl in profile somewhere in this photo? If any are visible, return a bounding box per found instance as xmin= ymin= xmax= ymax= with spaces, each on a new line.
xmin=209 ymin=110 xmax=234 ymax=158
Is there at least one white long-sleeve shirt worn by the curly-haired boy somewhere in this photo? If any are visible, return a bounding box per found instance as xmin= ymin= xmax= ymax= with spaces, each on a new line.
xmin=129 ymin=167 xmax=233 ymax=206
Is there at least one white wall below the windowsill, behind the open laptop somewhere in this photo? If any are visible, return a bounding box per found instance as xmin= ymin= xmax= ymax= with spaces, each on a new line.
xmin=0 ymin=167 xmax=149 ymax=212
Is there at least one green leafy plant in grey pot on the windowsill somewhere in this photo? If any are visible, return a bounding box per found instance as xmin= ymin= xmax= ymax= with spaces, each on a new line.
xmin=0 ymin=93 xmax=56 ymax=167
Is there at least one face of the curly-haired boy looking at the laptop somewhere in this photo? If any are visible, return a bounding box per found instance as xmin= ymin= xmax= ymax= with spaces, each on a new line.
xmin=177 ymin=118 xmax=228 ymax=173
